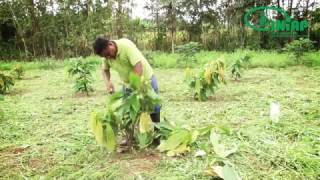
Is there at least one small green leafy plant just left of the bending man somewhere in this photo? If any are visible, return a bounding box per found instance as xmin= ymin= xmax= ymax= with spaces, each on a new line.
xmin=68 ymin=58 xmax=94 ymax=95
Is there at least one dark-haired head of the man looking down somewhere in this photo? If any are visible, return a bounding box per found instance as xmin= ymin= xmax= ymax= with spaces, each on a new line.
xmin=93 ymin=38 xmax=117 ymax=58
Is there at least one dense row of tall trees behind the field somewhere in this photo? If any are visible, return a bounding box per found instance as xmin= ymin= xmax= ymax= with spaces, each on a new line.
xmin=0 ymin=0 xmax=320 ymax=60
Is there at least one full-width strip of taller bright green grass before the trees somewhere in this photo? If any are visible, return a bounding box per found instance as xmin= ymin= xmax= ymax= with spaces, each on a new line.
xmin=0 ymin=49 xmax=320 ymax=71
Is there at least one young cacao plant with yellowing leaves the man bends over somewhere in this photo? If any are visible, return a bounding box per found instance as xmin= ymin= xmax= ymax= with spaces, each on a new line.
xmin=91 ymin=73 xmax=160 ymax=151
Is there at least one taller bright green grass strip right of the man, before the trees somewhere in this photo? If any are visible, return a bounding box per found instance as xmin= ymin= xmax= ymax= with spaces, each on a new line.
xmin=148 ymin=49 xmax=320 ymax=69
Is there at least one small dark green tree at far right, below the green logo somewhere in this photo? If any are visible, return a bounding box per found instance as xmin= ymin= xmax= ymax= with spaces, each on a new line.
xmin=285 ymin=38 xmax=313 ymax=64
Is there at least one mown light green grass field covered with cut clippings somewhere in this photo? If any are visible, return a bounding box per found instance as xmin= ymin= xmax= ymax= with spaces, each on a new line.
xmin=0 ymin=55 xmax=320 ymax=180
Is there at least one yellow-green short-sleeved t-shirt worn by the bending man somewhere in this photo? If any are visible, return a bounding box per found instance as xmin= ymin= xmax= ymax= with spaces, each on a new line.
xmin=102 ymin=38 xmax=153 ymax=83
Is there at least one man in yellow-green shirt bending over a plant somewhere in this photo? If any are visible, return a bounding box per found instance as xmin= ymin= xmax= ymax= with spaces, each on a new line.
xmin=93 ymin=38 xmax=160 ymax=145
